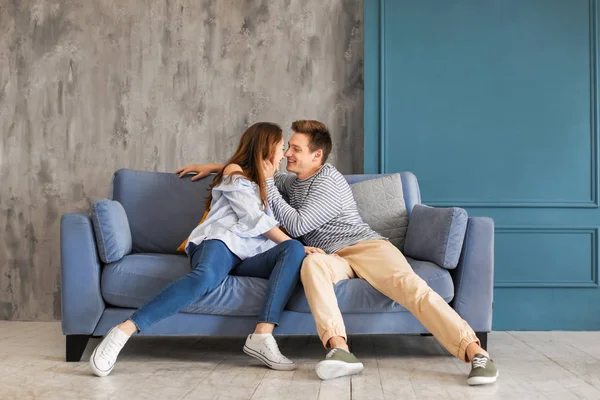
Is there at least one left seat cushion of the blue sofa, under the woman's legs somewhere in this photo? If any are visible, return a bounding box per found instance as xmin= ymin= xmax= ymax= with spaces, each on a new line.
xmin=101 ymin=254 xmax=267 ymax=316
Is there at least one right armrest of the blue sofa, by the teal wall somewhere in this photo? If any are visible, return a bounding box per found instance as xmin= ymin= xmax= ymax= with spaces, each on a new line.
xmin=450 ymin=217 xmax=494 ymax=332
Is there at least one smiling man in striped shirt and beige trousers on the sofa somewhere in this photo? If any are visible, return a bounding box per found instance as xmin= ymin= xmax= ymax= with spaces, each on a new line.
xmin=177 ymin=121 xmax=498 ymax=385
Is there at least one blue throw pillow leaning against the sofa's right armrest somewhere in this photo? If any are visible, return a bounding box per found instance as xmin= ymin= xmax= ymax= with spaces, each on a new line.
xmin=404 ymin=204 xmax=468 ymax=269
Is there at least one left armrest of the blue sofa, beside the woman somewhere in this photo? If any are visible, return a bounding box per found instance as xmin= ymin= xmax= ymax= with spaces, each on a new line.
xmin=60 ymin=214 xmax=105 ymax=335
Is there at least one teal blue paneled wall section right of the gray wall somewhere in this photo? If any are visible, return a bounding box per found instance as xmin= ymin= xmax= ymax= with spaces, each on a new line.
xmin=365 ymin=0 xmax=600 ymax=329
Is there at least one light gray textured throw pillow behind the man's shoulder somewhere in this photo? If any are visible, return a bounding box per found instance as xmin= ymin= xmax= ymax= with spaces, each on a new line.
xmin=350 ymin=174 xmax=408 ymax=251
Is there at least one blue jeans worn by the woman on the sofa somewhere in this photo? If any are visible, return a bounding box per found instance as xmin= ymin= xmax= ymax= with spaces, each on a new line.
xmin=130 ymin=240 xmax=304 ymax=331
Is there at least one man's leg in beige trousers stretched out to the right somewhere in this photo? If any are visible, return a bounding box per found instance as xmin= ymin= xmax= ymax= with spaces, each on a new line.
xmin=337 ymin=240 xmax=495 ymax=383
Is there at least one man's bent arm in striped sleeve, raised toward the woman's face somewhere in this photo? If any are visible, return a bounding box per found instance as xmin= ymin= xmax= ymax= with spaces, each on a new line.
xmin=267 ymin=176 xmax=342 ymax=237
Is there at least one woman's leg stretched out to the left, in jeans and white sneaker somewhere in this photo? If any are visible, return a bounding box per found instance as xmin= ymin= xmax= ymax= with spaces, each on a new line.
xmin=90 ymin=240 xmax=240 ymax=376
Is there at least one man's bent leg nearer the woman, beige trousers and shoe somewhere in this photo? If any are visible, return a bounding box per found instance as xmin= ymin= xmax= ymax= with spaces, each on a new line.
xmin=300 ymin=254 xmax=363 ymax=379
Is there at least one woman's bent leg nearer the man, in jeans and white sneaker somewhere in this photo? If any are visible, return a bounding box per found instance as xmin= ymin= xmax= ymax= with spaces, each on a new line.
xmin=232 ymin=240 xmax=304 ymax=370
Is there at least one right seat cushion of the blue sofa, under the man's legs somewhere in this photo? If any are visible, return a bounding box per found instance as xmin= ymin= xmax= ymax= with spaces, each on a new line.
xmin=287 ymin=258 xmax=454 ymax=313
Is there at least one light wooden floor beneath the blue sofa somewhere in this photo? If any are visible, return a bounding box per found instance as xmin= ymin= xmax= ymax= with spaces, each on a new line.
xmin=0 ymin=321 xmax=600 ymax=400
